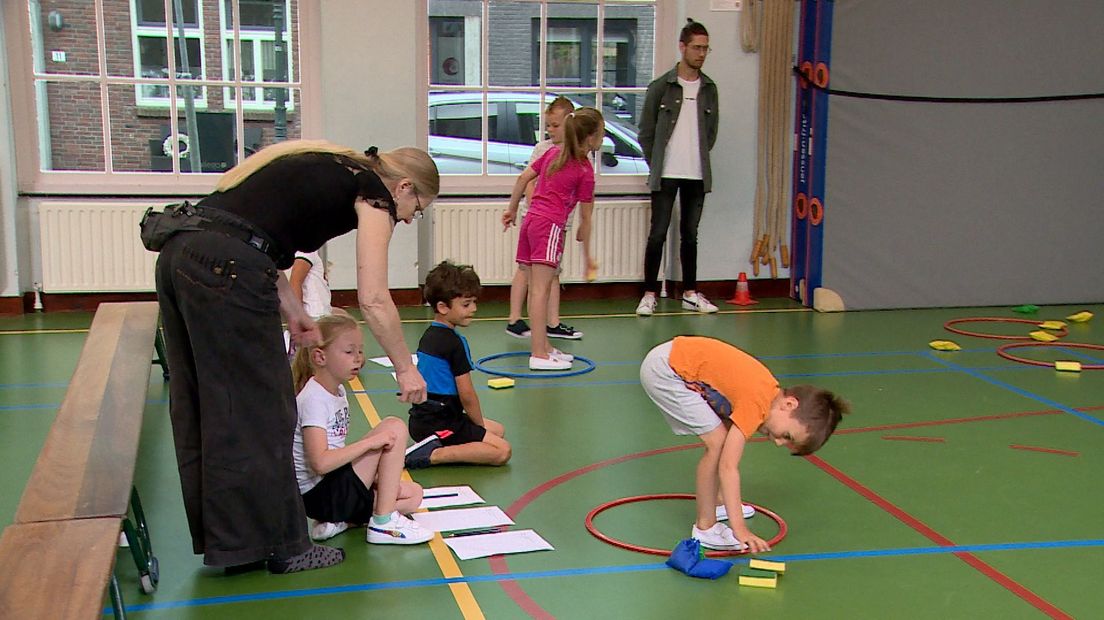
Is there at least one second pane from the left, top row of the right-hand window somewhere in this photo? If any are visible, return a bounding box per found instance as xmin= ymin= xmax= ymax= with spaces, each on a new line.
xmin=487 ymin=1 xmax=541 ymax=86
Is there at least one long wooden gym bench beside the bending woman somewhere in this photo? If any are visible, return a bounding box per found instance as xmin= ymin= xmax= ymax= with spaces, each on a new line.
xmin=0 ymin=302 xmax=159 ymax=618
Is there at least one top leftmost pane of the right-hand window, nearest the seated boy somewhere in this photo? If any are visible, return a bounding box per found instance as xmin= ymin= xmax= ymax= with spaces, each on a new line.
xmin=429 ymin=0 xmax=482 ymax=86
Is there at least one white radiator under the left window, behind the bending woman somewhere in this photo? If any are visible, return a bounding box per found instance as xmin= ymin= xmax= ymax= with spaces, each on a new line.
xmin=38 ymin=201 xmax=157 ymax=292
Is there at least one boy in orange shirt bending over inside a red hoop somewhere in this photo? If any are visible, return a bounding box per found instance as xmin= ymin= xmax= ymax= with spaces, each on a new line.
xmin=640 ymin=335 xmax=850 ymax=553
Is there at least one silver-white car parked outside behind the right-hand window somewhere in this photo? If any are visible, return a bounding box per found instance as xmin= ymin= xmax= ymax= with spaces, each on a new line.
xmin=429 ymin=93 xmax=648 ymax=174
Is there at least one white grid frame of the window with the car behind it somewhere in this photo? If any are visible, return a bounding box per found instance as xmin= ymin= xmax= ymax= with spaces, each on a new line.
xmin=418 ymin=0 xmax=657 ymax=195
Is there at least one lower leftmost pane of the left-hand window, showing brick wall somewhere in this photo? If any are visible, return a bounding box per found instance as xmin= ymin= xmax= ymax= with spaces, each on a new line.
xmin=35 ymin=81 xmax=105 ymax=172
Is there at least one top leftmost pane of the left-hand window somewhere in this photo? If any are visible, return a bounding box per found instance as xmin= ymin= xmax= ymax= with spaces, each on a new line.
xmin=31 ymin=2 xmax=99 ymax=75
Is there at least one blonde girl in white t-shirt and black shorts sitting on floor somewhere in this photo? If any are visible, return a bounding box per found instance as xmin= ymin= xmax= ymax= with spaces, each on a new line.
xmin=291 ymin=314 xmax=434 ymax=545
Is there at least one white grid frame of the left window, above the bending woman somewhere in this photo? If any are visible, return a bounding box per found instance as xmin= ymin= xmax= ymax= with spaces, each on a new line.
xmin=2 ymin=0 xmax=322 ymax=199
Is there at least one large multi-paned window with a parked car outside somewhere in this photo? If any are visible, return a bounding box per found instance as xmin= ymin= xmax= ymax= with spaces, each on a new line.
xmin=427 ymin=0 xmax=656 ymax=188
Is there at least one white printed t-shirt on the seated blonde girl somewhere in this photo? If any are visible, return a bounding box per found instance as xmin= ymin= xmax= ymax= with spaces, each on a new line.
xmin=291 ymin=377 xmax=349 ymax=494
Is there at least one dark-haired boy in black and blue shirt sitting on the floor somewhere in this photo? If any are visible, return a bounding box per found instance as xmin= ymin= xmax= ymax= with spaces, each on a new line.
xmin=406 ymin=260 xmax=510 ymax=469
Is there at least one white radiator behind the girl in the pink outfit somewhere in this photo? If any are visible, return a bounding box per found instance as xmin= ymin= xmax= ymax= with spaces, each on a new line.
xmin=433 ymin=200 xmax=650 ymax=285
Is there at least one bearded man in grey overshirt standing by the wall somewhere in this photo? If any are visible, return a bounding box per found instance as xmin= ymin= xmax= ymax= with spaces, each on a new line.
xmin=636 ymin=20 xmax=719 ymax=317
